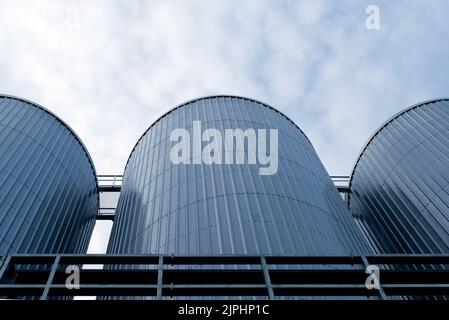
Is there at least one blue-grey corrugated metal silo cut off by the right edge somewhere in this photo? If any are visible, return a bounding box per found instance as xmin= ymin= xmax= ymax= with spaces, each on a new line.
xmin=349 ymin=99 xmax=449 ymax=253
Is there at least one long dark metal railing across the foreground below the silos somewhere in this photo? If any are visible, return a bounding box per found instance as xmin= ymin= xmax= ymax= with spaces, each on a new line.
xmin=0 ymin=255 xmax=449 ymax=300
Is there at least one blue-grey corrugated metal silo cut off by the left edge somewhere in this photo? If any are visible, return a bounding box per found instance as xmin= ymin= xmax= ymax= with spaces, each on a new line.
xmin=0 ymin=95 xmax=98 ymax=254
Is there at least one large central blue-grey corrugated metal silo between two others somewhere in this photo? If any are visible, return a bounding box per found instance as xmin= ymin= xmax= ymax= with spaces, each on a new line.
xmin=108 ymin=96 xmax=367 ymax=254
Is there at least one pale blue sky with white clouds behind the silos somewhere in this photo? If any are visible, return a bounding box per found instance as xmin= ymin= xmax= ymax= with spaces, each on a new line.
xmin=0 ymin=0 xmax=449 ymax=252
